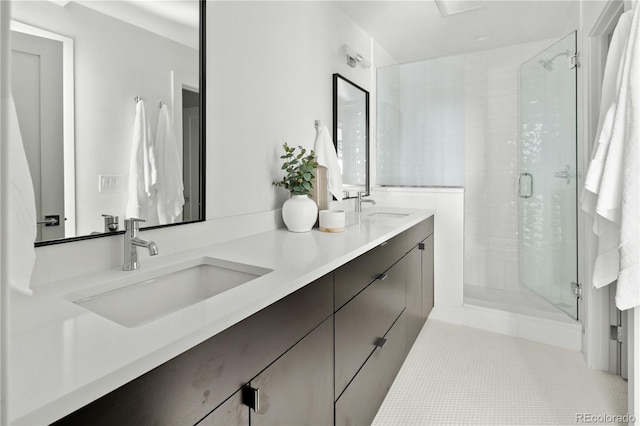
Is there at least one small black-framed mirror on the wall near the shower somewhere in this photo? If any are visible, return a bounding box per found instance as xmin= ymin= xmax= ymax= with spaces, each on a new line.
xmin=333 ymin=74 xmax=370 ymax=198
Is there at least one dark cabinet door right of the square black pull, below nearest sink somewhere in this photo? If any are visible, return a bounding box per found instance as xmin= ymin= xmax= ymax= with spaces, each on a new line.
xmin=251 ymin=318 xmax=333 ymax=426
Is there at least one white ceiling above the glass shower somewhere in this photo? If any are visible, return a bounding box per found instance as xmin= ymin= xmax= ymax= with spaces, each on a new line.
xmin=335 ymin=0 xmax=579 ymax=63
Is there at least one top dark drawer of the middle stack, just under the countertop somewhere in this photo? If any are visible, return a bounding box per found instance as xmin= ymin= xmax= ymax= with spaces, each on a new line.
xmin=335 ymin=233 xmax=406 ymax=310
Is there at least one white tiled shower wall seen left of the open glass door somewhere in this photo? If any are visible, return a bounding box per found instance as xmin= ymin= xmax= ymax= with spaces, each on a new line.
xmin=464 ymin=40 xmax=550 ymax=291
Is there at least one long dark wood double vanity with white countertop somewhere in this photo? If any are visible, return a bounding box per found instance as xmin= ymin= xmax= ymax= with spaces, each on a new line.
xmin=11 ymin=211 xmax=434 ymax=425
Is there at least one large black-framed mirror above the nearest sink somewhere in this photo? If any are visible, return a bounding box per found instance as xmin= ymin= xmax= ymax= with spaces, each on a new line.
xmin=11 ymin=0 xmax=206 ymax=247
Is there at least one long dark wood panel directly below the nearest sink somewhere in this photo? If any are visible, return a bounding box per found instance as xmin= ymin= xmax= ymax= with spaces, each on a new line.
xmin=55 ymin=274 xmax=333 ymax=425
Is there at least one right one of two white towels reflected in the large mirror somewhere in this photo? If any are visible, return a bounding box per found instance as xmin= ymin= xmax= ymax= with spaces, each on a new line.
xmin=155 ymin=105 xmax=184 ymax=225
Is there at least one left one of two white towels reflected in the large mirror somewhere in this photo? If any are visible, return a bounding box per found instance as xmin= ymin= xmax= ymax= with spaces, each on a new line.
xmin=126 ymin=100 xmax=157 ymax=219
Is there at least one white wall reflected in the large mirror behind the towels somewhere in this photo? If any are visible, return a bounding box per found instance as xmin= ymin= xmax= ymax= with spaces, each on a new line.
xmin=12 ymin=1 xmax=198 ymax=235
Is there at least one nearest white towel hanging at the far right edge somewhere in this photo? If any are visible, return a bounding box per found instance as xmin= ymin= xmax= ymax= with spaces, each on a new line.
xmin=611 ymin=7 xmax=640 ymax=310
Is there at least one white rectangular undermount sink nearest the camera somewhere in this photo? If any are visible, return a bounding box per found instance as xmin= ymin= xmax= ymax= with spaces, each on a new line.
xmin=65 ymin=257 xmax=272 ymax=327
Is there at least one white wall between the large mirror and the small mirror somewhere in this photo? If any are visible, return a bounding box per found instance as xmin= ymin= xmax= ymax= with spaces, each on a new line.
xmin=207 ymin=1 xmax=373 ymax=219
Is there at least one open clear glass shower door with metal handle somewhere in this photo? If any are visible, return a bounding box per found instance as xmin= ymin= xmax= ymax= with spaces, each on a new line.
xmin=516 ymin=32 xmax=578 ymax=319
